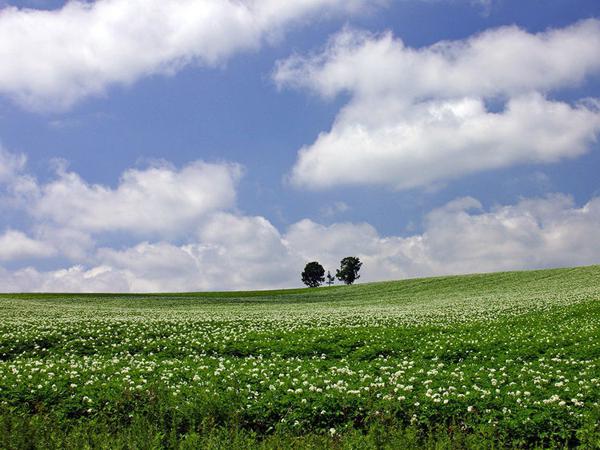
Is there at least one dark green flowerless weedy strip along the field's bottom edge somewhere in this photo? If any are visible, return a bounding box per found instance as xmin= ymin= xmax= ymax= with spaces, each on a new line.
xmin=0 ymin=417 xmax=556 ymax=450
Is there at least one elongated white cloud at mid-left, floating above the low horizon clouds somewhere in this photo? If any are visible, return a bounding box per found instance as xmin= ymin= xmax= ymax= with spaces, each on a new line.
xmin=27 ymin=161 xmax=241 ymax=235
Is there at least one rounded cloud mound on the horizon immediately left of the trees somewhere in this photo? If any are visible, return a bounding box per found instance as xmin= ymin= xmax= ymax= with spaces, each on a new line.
xmin=98 ymin=213 xmax=302 ymax=291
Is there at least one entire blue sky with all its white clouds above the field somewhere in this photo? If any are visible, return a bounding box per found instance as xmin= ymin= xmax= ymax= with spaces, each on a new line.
xmin=0 ymin=0 xmax=600 ymax=291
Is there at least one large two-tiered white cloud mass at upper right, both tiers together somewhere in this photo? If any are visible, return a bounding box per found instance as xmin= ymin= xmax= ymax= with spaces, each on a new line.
xmin=274 ymin=19 xmax=600 ymax=189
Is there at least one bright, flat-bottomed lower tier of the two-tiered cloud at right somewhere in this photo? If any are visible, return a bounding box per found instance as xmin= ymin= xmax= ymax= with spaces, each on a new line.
xmin=292 ymin=94 xmax=600 ymax=189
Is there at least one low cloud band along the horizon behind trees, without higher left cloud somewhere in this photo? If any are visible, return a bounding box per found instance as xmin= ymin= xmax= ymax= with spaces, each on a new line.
xmin=0 ymin=194 xmax=600 ymax=292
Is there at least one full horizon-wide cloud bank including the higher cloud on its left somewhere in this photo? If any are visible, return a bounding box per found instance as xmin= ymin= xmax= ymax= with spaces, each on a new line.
xmin=0 ymin=148 xmax=600 ymax=292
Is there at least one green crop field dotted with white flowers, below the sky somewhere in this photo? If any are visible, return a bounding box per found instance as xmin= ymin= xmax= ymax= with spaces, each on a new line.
xmin=0 ymin=266 xmax=600 ymax=448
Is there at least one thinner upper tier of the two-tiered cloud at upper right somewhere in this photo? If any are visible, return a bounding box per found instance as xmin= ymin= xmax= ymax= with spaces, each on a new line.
xmin=274 ymin=19 xmax=600 ymax=99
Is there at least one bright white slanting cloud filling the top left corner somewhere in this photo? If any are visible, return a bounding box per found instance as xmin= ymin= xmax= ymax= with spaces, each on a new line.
xmin=0 ymin=0 xmax=367 ymax=109
